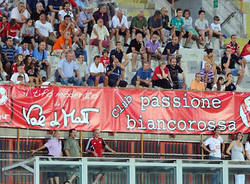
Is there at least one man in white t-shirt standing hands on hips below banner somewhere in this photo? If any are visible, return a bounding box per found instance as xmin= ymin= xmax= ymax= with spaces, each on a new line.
xmin=201 ymin=127 xmax=225 ymax=184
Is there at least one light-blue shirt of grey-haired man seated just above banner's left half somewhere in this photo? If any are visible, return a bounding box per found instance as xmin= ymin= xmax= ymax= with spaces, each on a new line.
xmin=58 ymin=59 xmax=78 ymax=78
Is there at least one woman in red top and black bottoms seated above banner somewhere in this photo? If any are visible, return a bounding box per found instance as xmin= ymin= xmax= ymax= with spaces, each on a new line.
xmin=152 ymin=62 xmax=173 ymax=89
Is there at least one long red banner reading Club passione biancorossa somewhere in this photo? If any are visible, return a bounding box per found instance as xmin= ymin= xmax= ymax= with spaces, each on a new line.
xmin=0 ymin=85 xmax=250 ymax=134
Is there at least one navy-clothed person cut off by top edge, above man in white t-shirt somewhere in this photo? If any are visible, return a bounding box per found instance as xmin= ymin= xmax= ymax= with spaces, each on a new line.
xmin=48 ymin=0 xmax=63 ymax=27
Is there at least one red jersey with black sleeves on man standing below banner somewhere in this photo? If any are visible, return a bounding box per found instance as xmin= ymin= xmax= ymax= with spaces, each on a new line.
xmin=86 ymin=137 xmax=106 ymax=157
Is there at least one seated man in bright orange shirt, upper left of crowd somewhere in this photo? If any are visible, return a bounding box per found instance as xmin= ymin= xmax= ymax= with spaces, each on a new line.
xmin=52 ymin=31 xmax=72 ymax=52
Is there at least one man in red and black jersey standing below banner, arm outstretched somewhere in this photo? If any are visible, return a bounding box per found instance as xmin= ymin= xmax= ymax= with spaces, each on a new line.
xmin=85 ymin=129 xmax=116 ymax=184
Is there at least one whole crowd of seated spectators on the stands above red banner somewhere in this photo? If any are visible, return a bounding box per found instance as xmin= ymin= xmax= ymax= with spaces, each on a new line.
xmin=0 ymin=0 xmax=250 ymax=91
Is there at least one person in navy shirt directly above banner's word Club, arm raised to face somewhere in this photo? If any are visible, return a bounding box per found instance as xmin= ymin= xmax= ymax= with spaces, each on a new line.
xmin=106 ymin=58 xmax=128 ymax=87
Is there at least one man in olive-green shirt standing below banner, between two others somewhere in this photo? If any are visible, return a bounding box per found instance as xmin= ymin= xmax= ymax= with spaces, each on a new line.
xmin=63 ymin=129 xmax=82 ymax=183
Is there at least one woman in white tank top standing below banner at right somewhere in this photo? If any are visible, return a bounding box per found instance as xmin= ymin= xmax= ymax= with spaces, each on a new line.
xmin=227 ymin=132 xmax=245 ymax=184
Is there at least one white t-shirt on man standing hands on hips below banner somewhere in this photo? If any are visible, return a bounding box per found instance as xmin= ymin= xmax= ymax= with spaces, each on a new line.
xmin=204 ymin=136 xmax=224 ymax=158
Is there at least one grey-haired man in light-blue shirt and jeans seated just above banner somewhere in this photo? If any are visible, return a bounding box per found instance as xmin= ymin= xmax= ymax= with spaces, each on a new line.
xmin=57 ymin=50 xmax=82 ymax=86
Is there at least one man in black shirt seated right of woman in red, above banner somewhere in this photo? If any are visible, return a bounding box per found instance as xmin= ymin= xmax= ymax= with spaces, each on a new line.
xmin=167 ymin=56 xmax=186 ymax=89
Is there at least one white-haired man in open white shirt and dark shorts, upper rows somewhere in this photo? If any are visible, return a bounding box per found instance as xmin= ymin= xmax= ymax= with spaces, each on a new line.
xmin=112 ymin=9 xmax=130 ymax=47
